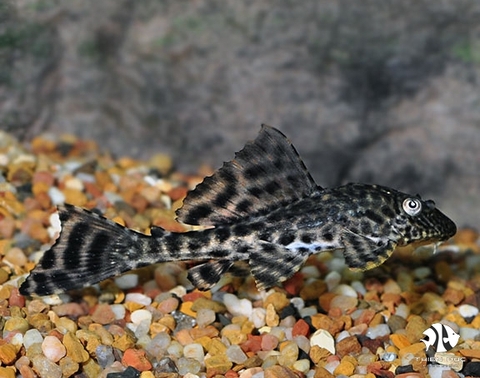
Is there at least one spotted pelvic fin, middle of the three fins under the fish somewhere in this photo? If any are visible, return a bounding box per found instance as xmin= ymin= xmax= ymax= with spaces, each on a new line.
xmin=249 ymin=242 xmax=310 ymax=290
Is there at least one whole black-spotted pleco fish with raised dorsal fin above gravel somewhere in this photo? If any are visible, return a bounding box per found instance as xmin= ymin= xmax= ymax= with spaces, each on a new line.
xmin=20 ymin=126 xmax=456 ymax=295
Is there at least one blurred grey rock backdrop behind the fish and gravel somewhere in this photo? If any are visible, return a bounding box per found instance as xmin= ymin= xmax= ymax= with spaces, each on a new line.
xmin=0 ymin=0 xmax=480 ymax=228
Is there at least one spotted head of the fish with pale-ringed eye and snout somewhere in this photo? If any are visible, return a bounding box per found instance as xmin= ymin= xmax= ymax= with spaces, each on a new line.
xmin=393 ymin=192 xmax=457 ymax=245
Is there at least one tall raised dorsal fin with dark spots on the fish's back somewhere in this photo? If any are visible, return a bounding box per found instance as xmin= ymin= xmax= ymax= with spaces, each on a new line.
xmin=177 ymin=125 xmax=319 ymax=226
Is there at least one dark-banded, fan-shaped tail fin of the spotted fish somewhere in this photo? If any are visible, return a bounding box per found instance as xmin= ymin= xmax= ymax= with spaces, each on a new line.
xmin=20 ymin=205 xmax=147 ymax=295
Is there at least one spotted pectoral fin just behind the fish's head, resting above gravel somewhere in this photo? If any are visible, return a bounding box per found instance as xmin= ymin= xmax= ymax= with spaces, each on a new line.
xmin=341 ymin=229 xmax=397 ymax=270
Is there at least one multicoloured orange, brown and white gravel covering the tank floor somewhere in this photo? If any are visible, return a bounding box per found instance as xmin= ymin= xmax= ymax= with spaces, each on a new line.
xmin=0 ymin=132 xmax=480 ymax=378
